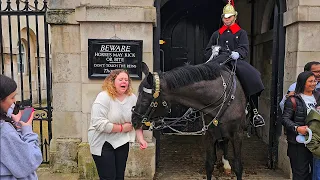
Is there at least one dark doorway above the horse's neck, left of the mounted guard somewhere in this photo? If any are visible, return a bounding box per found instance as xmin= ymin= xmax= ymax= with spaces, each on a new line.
xmin=161 ymin=0 xmax=224 ymax=71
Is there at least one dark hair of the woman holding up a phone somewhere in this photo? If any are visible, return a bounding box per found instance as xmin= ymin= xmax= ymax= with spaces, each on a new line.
xmin=0 ymin=74 xmax=17 ymax=128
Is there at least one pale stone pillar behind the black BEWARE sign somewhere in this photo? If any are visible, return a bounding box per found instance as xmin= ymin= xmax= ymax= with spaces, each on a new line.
xmin=48 ymin=0 xmax=156 ymax=179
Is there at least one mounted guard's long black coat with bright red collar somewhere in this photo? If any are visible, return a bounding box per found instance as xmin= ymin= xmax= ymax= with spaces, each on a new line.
xmin=205 ymin=24 xmax=264 ymax=96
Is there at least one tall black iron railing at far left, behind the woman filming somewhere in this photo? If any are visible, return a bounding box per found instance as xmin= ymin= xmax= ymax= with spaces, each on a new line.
xmin=0 ymin=0 xmax=52 ymax=163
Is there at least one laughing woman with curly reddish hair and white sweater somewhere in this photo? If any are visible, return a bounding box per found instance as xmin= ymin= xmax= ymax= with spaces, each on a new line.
xmin=88 ymin=69 xmax=147 ymax=180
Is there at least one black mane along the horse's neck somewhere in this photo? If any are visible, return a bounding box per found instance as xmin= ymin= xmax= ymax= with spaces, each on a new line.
xmin=161 ymin=61 xmax=224 ymax=89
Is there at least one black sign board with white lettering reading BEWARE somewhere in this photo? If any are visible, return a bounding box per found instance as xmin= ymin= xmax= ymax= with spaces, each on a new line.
xmin=88 ymin=39 xmax=142 ymax=79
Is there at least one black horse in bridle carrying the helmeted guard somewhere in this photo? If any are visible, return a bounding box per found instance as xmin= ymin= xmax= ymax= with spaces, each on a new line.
xmin=132 ymin=57 xmax=246 ymax=180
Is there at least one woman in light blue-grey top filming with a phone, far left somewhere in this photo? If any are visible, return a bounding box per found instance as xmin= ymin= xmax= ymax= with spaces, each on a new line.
xmin=0 ymin=75 xmax=42 ymax=180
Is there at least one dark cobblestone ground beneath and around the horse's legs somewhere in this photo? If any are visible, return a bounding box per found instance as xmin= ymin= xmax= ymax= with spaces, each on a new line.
xmin=154 ymin=135 xmax=288 ymax=180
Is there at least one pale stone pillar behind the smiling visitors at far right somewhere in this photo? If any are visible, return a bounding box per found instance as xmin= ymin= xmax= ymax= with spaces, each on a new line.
xmin=279 ymin=0 xmax=320 ymax=177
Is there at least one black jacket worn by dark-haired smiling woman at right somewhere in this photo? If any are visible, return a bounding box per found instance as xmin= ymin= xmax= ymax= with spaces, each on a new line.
xmin=281 ymin=92 xmax=320 ymax=144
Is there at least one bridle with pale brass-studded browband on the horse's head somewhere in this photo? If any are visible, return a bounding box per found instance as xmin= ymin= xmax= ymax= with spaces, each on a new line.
xmin=131 ymin=72 xmax=171 ymax=126
